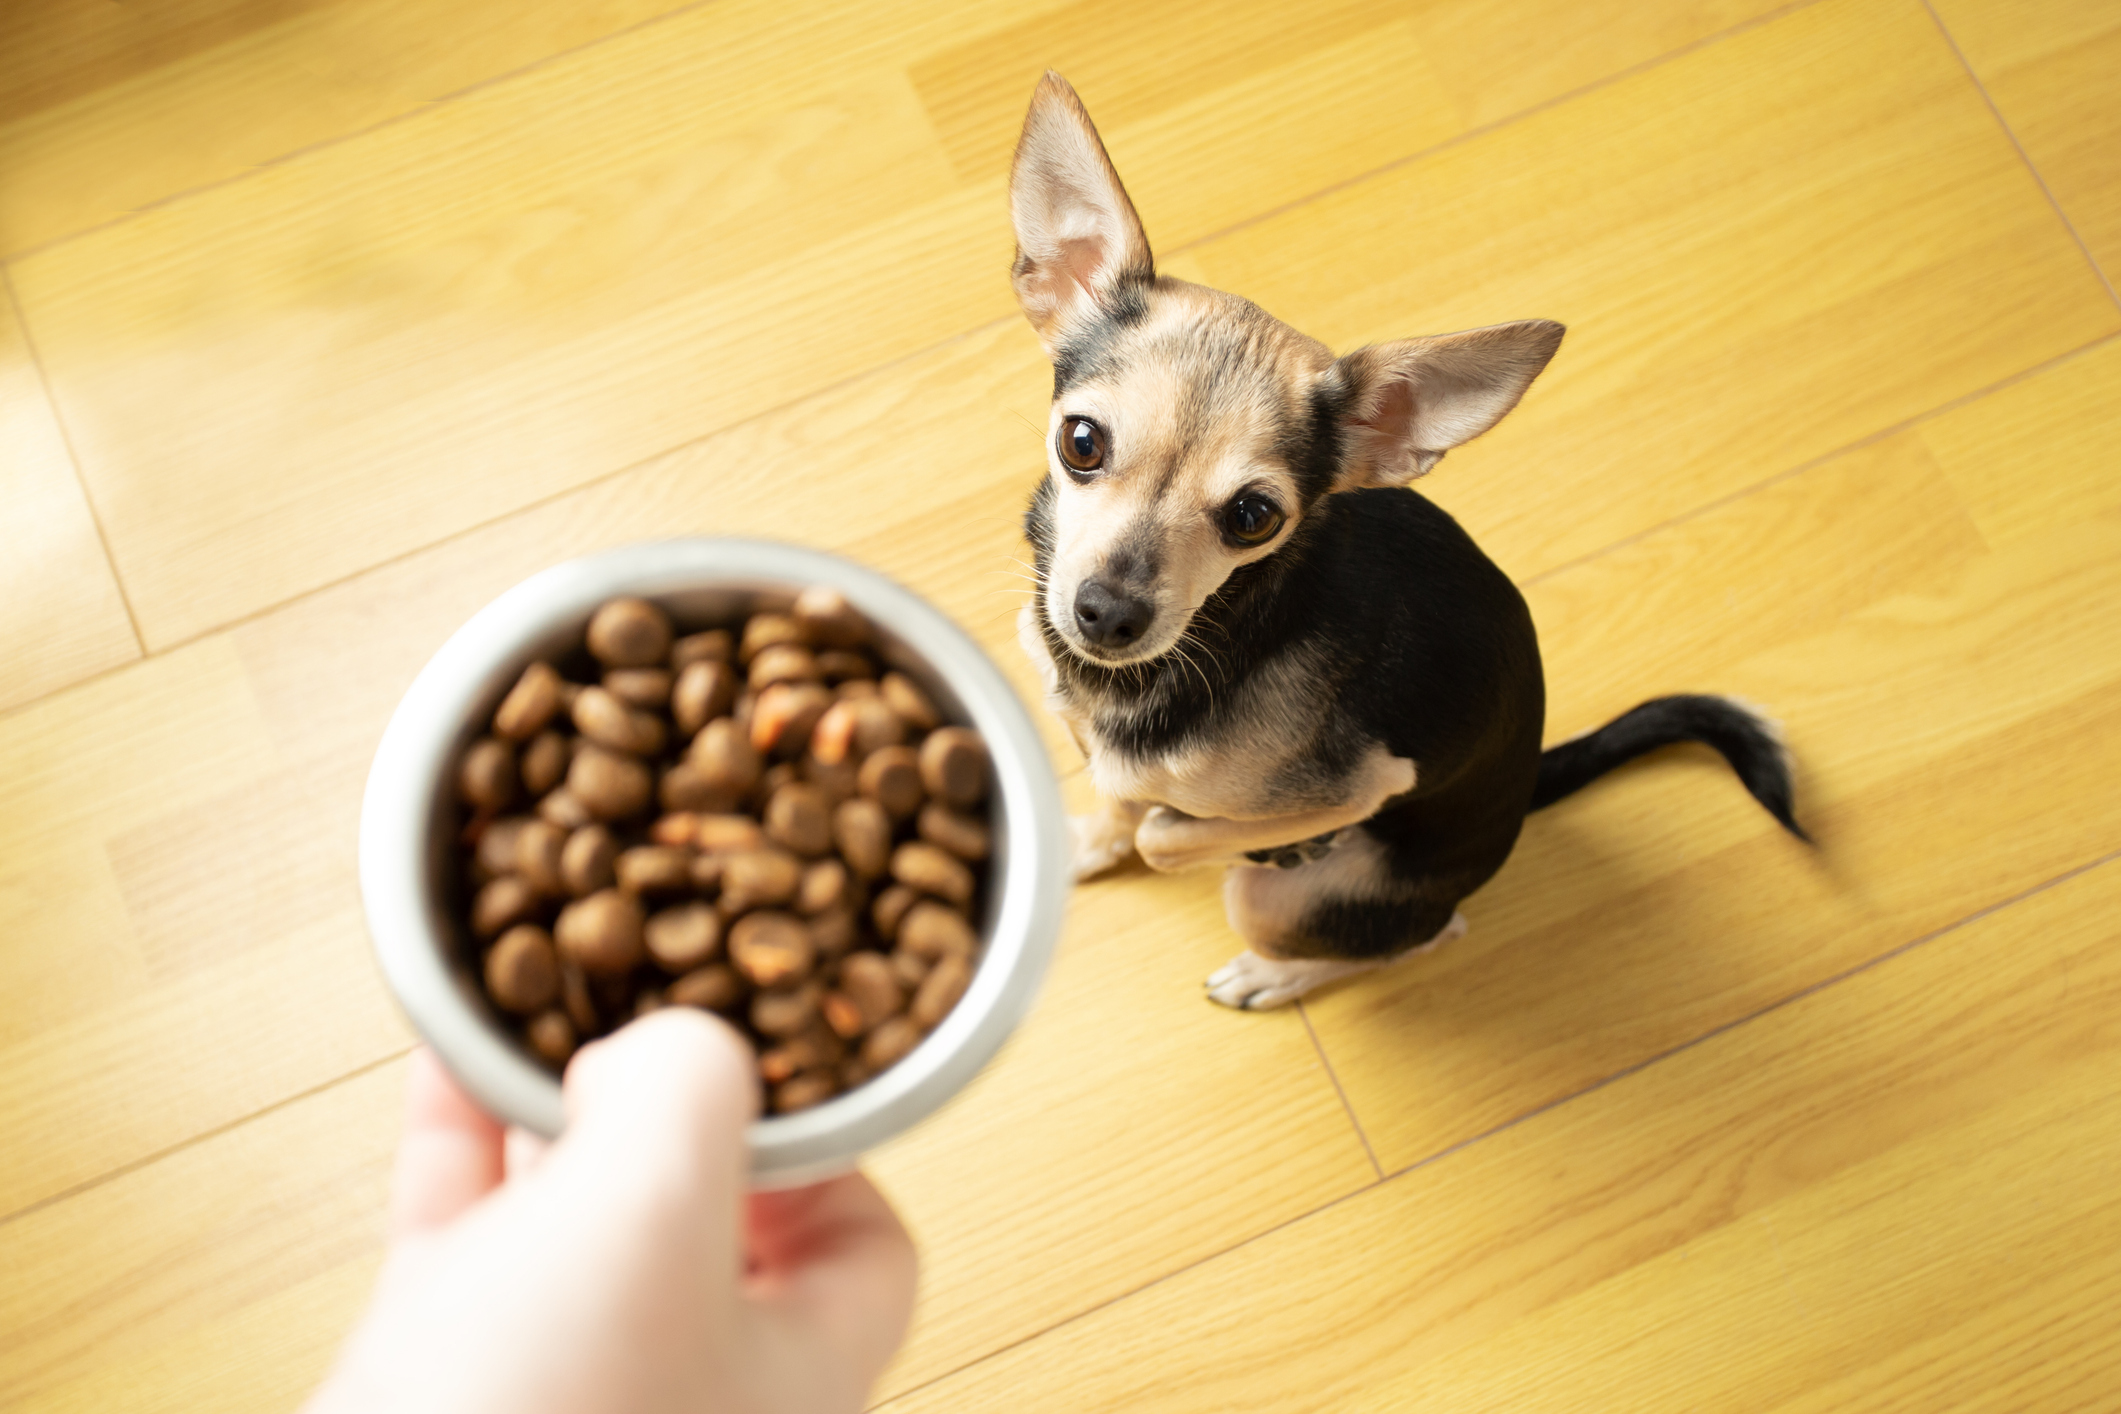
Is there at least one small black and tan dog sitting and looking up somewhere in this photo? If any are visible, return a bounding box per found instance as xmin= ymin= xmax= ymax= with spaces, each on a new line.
xmin=1010 ymin=74 xmax=1803 ymax=1009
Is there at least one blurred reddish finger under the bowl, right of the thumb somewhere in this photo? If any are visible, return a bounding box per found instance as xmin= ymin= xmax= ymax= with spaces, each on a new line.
xmin=744 ymin=1172 xmax=918 ymax=1380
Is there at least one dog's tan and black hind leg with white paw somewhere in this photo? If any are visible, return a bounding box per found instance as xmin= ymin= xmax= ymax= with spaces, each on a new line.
xmin=1207 ymin=829 xmax=1466 ymax=1011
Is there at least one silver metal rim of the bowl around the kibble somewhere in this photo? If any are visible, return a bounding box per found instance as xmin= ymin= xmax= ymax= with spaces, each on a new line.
xmin=358 ymin=536 xmax=1069 ymax=1187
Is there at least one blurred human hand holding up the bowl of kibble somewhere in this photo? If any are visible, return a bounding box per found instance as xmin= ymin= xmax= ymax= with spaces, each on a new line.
xmin=308 ymin=1007 xmax=914 ymax=1414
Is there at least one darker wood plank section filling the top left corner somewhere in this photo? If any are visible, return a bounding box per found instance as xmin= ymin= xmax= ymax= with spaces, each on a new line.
xmin=0 ymin=0 xmax=712 ymax=257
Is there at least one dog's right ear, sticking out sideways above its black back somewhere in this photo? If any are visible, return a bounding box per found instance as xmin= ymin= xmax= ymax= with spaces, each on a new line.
xmin=1334 ymin=320 xmax=1561 ymax=492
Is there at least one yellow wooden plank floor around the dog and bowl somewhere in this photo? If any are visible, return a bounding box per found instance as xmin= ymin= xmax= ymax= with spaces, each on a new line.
xmin=0 ymin=0 xmax=2121 ymax=1414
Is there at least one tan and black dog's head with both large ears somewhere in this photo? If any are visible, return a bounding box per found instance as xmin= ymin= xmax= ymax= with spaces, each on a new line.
xmin=1010 ymin=74 xmax=1561 ymax=666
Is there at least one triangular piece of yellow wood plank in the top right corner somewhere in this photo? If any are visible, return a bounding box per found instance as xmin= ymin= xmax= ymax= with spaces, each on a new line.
xmin=1932 ymin=0 xmax=2121 ymax=284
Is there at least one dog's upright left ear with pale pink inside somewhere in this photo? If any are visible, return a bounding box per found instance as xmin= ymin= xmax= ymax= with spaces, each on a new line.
xmin=1010 ymin=70 xmax=1156 ymax=354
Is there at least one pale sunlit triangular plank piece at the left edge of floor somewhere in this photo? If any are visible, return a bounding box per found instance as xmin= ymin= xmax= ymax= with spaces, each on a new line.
xmin=0 ymin=295 xmax=140 ymax=710
